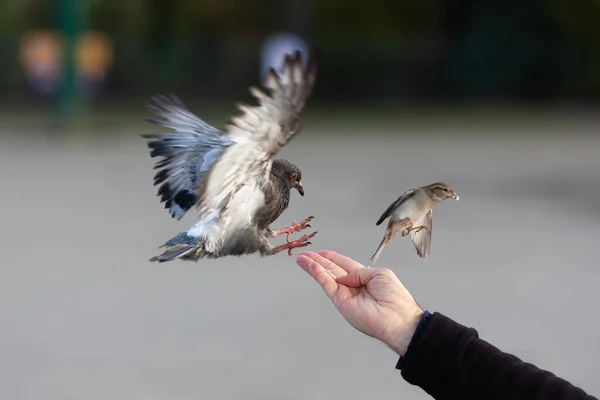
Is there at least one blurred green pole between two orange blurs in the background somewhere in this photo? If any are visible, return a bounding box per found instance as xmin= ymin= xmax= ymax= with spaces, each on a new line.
xmin=56 ymin=0 xmax=88 ymax=120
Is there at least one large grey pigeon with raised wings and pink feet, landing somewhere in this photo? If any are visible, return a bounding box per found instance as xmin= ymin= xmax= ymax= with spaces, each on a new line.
xmin=141 ymin=49 xmax=319 ymax=262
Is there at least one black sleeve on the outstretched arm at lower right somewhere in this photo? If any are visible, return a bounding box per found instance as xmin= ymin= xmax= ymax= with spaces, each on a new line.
xmin=396 ymin=312 xmax=598 ymax=400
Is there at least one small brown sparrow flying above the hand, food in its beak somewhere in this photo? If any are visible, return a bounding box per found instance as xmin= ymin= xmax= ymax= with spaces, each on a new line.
xmin=371 ymin=182 xmax=459 ymax=263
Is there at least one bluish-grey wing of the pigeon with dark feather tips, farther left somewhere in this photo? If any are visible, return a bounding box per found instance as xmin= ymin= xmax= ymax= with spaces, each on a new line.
xmin=141 ymin=96 xmax=236 ymax=220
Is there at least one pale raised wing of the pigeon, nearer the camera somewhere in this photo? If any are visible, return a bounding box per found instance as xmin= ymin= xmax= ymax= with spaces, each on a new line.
xmin=196 ymin=51 xmax=317 ymax=222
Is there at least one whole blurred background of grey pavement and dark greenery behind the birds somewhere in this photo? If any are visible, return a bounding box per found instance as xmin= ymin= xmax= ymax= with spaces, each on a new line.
xmin=0 ymin=0 xmax=600 ymax=400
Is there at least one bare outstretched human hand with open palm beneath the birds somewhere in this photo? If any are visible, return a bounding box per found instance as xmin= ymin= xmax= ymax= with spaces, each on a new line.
xmin=296 ymin=250 xmax=423 ymax=356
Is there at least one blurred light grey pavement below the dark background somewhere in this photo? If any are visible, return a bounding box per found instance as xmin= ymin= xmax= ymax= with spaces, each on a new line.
xmin=0 ymin=131 xmax=600 ymax=400
